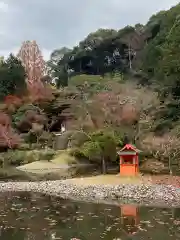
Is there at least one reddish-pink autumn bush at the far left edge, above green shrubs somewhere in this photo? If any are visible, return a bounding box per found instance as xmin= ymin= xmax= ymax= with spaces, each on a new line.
xmin=0 ymin=112 xmax=21 ymax=149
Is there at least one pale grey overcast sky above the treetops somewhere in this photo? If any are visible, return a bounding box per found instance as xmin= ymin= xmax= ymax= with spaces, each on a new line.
xmin=0 ymin=0 xmax=179 ymax=59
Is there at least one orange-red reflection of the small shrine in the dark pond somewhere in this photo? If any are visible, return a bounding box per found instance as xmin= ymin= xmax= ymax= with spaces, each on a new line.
xmin=121 ymin=205 xmax=139 ymax=234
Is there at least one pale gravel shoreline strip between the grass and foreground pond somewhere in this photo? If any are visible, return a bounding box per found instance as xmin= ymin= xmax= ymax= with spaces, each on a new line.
xmin=0 ymin=180 xmax=180 ymax=207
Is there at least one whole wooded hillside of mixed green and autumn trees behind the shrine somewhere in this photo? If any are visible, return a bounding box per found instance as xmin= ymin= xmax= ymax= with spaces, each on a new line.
xmin=0 ymin=1 xmax=180 ymax=174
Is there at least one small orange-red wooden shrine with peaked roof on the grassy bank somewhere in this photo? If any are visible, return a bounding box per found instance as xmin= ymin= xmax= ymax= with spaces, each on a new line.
xmin=118 ymin=144 xmax=140 ymax=176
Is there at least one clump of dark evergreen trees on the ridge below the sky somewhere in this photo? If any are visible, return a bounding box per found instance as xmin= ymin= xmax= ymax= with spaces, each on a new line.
xmin=46 ymin=25 xmax=151 ymax=86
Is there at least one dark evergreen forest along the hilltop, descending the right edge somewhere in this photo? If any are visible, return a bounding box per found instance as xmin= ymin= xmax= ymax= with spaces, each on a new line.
xmin=49 ymin=4 xmax=180 ymax=132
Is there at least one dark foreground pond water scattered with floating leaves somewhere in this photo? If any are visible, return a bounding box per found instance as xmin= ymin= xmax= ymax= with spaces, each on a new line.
xmin=0 ymin=193 xmax=180 ymax=240
